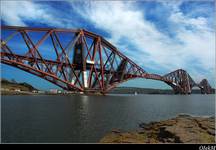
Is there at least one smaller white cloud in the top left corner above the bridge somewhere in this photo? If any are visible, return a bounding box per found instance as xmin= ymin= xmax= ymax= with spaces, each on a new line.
xmin=1 ymin=1 xmax=65 ymax=26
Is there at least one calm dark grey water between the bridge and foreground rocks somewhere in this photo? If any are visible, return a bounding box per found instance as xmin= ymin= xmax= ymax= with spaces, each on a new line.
xmin=1 ymin=95 xmax=215 ymax=143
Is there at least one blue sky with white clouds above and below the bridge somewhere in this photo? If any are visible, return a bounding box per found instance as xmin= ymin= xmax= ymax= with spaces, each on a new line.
xmin=1 ymin=0 xmax=215 ymax=89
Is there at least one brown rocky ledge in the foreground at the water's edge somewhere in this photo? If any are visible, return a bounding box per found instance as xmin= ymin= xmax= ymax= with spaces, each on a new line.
xmin=100 ymin=115 xmax=215 ymax=143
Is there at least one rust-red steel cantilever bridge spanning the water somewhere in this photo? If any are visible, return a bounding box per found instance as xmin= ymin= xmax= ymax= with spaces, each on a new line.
xmin=1 ymin=26 xmax=211 ymax=94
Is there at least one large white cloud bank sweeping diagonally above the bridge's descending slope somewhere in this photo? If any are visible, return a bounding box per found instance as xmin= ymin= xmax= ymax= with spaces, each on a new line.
xmin=72 ymin=1 xmax=215 ymax=83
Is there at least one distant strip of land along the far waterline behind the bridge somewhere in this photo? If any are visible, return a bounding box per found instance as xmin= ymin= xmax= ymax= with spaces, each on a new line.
xmin=1 ymin=79 xmax=215 ymax=95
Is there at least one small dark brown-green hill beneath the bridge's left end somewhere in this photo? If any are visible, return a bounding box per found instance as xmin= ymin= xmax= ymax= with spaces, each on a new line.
xmin=1 ymin=79 xmax=37 ymax=91
